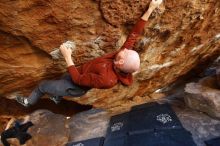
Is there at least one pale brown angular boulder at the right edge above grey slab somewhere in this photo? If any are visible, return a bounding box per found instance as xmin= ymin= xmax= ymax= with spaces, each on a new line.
xmin=185 ymin=77 xmax=220 ymax=119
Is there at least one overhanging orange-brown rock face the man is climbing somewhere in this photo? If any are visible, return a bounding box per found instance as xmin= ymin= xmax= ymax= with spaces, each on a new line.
xmin=0 ymin=0 xmax=220 ymax=113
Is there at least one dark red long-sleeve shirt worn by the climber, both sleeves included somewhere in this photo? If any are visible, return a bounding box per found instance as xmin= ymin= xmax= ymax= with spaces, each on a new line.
xmin=67 ymin=19 xmax=146 ymax=89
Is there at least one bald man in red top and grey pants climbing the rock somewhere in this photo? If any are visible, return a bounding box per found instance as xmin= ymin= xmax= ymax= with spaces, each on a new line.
xmin=16 ymin=0 xmax=162 ymax=107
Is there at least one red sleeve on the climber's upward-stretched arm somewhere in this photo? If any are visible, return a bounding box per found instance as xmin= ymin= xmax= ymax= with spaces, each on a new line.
xmin=121 ymin=19 xmax=147 ymax=49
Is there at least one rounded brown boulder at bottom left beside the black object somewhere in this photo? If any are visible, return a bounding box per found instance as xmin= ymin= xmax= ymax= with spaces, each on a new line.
xmin=26 ymin=110 xmax=70 ymax=146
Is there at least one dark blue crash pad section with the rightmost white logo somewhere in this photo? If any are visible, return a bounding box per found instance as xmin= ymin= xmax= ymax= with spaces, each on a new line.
xmin=129 ymin=103 xmax=183 ymax=134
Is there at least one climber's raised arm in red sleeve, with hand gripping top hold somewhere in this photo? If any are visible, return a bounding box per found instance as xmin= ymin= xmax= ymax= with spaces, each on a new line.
xmin=121 ymin=0 xmax=162 ymax=49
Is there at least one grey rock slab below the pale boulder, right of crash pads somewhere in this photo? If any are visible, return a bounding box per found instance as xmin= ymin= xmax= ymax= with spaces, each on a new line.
xmin=174 ymin=106 xmax=220 ymax=146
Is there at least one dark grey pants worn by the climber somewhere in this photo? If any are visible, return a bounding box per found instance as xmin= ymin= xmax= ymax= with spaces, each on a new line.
xmin=28 ymin=74 xmax=89 ymax=105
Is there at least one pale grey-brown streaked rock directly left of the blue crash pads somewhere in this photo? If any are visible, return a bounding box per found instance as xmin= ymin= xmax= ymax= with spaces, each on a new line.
xmin=68 ymin=109 xmax=110 ymax=141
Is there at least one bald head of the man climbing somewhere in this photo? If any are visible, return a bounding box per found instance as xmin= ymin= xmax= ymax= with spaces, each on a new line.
xmin=114 ymin=49 xmax=140 ymax=73
